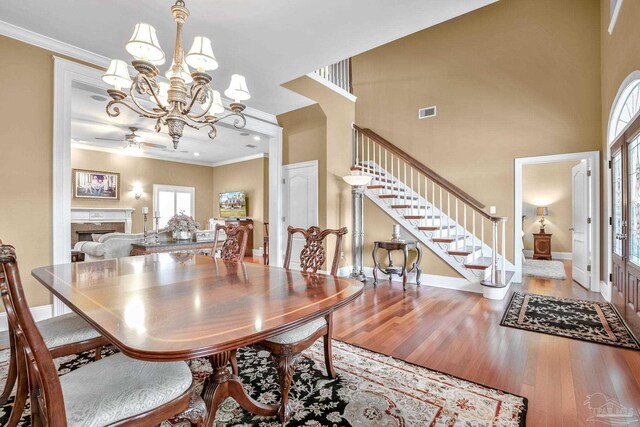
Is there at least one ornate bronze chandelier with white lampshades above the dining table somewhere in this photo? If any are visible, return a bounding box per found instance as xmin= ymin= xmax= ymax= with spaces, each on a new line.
xmin=102 ymin=0 xmax=251 ymax=149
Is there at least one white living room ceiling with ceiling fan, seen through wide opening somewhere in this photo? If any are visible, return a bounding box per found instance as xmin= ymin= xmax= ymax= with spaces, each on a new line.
xmin=71 ymin=84 xmax=269 ymax=166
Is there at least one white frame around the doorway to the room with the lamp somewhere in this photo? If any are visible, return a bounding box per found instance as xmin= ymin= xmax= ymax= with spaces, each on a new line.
xmin=513 ymin=151 xmax=600 ymax=292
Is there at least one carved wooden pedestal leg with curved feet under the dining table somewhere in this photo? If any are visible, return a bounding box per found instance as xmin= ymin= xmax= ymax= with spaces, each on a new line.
xmin=202 ymin=351 xmax=278 ymax=426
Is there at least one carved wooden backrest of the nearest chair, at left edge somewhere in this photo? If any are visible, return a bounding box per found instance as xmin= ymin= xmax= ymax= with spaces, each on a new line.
xmin=0 ymin=245 xmax=67 ymax=427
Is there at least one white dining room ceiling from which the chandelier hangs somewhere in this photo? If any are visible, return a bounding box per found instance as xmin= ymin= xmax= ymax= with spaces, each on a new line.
xmin=0 ymin=0 xmax=496 ymax=114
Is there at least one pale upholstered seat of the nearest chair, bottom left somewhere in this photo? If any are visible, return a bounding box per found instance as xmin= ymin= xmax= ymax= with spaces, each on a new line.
xmin=60 ymin=354 xmax=193 ymax=427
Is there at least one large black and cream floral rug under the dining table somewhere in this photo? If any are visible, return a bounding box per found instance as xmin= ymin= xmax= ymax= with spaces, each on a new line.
xmin=0 ymin=341 xmax=527 ymax=427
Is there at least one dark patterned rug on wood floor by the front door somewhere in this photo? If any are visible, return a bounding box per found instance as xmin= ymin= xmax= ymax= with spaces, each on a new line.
xmin=500 ymin=292 xmax=640 ymax=350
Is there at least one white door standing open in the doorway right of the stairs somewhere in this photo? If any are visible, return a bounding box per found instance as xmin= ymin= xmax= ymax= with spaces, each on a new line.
xmin=571 ymin=161 xmax=590 ymax=289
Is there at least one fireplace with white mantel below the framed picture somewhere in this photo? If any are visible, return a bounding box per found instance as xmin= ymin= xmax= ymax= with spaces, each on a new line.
xmin=71 ymin=208 xmax=133 ymax=248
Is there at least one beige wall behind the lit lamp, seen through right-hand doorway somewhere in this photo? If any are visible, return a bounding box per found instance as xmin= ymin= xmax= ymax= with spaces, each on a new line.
xmin=522 ymin=161 xmax=578 ymax=252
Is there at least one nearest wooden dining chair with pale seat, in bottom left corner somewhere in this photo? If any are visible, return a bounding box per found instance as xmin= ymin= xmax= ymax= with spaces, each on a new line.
xmin=0 ymin=245 xmax=207 ymax=427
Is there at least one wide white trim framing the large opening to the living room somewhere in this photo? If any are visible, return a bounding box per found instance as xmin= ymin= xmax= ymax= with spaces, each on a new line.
xmin=52 ymin=55 xmax=284 ymax=316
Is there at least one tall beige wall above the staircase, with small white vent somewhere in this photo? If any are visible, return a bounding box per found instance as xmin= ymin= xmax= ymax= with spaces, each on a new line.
xmin=352 ymin=0 xmax=601 ymax=271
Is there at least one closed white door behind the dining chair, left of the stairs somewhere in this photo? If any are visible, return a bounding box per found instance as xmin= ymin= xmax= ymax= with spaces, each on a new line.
xmin=282 ymin=161 xmax=318 ymax=269
